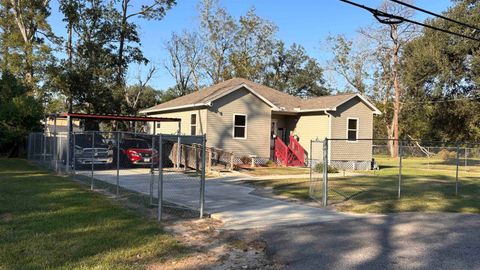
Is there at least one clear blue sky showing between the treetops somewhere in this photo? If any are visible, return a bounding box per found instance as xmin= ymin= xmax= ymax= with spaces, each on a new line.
xmin=49 ymin=0 xmax=452 ymax=90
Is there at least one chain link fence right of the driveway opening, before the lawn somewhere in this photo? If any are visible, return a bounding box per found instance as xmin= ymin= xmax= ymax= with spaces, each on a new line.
xmin=310 ymin=139 xmax=480 ymax=208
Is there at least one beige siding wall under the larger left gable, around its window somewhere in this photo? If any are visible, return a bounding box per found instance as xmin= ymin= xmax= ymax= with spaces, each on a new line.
xmin=207 ymin=89 xmax=271 ymax=158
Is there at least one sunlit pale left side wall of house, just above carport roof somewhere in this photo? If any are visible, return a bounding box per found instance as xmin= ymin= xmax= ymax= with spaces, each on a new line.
xmin=148 ymin=109 xmax=207 ymax=135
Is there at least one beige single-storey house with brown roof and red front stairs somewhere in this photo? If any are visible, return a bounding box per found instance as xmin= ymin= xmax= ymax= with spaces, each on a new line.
xmin=141 ymin=78 xmax=380 ymax=169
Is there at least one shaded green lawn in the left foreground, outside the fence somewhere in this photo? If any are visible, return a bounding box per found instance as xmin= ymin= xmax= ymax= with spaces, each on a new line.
xmin=0 ymin=159 xmax=188 ymax=269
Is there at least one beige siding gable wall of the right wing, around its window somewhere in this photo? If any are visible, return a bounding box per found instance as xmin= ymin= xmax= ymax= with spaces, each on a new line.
xmin=329 ymin=97 xmax=373 ymax=161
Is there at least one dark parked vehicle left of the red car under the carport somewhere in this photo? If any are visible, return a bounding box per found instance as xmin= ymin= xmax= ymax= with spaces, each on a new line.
xmin=74 ymin=134 xmax=113 ymax=165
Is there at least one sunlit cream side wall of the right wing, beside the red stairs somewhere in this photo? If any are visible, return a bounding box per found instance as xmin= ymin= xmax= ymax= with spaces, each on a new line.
xmin=293 ymin=113 xmax=329 ymax=159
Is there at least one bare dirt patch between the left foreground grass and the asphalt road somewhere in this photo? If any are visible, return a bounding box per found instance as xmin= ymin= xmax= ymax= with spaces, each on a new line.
xmin=148 ymin=218 xmax=282 ymax=270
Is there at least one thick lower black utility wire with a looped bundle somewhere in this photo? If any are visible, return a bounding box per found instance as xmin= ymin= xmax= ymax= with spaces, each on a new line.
xmin=340 ymin=0 xmax=480 ymax=41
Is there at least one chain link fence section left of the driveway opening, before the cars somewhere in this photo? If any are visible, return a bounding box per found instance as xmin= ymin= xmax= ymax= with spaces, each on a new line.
xmin=28 ymin=131 xmax=207 ymax=220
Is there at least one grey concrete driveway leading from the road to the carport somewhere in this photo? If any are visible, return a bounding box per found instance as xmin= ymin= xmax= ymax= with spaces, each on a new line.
xmin=77 ymin=169 xmax=355 ymax=229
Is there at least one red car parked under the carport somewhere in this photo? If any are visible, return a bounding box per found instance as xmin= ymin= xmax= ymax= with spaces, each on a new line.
xmin=120 ymin=138 xmax=158 ymax=166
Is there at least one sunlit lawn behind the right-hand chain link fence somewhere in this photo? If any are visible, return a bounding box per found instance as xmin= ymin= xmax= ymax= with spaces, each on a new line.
xmin=242 ymin=157 xmax=480 ymax=213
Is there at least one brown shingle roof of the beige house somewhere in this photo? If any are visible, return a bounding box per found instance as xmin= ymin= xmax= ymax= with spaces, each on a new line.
xmin=142 ymin=78 xmax=376 ymax=112
